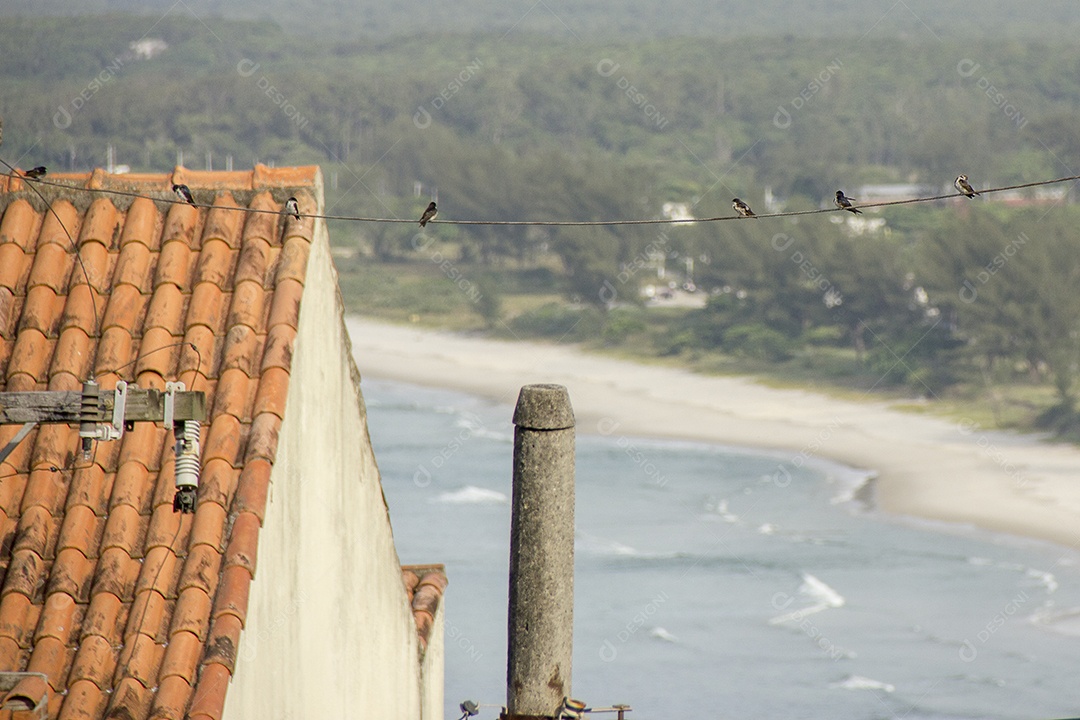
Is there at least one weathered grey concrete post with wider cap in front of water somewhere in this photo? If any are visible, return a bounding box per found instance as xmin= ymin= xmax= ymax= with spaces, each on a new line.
xmin=507 ymin=384 xmax=575 ymax=718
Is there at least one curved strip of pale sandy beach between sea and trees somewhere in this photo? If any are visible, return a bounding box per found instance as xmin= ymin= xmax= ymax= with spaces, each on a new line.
xmin=346 ymin=316 xmax=1080 ymax=547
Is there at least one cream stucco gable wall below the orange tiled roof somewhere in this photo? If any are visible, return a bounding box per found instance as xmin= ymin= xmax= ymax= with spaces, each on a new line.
xmin=225 ymin=181 xmax=443 ymax=720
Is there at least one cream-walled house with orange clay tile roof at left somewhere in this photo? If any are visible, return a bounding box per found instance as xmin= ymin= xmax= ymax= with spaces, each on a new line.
xmin=0 ymin=165 xmax=446 ymax=720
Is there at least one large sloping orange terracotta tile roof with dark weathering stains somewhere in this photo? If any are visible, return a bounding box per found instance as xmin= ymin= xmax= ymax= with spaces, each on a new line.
xmin=0 ymin=166 xmax=341 ymax=720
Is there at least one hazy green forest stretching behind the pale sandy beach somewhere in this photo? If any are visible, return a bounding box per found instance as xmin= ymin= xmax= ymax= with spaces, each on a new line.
xmin=6 ymin=12 xmax=1080 ymax=437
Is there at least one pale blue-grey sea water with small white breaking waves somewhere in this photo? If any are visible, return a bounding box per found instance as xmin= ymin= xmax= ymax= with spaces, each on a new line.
xmin=363 ymin=379 xmax=1080 ymax=720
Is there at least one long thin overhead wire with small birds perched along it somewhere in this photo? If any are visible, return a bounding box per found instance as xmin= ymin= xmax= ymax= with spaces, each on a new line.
xmin=0 ymin=167 xmax=1080 ymax=227
